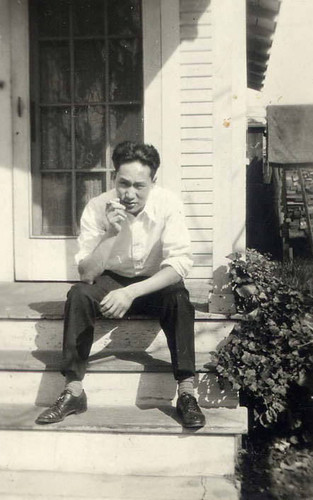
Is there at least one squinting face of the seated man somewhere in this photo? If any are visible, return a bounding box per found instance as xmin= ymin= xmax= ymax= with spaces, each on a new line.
xmin=115 ymin=161 xmax=154 ymax=215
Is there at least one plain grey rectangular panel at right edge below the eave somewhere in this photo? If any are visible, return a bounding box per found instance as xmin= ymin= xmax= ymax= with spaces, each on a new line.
xmin=267 ymin=104 xmax=313 ymax=165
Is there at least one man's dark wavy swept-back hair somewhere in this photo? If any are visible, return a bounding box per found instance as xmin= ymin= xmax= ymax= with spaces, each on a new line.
xmin=112 ymin=141 xmax=160 ymax=179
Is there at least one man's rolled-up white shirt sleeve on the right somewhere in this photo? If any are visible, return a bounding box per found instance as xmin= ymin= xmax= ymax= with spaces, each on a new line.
xmin=160 ymin=200 xmax=192 ymax=278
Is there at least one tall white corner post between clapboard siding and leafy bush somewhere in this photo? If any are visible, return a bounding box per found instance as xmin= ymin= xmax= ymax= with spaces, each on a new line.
xmin=209 ymin=0 xmax=247 ymax=313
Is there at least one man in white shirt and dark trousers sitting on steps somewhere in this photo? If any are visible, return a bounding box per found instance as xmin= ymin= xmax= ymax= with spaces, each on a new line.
xmin=36 ymin=142 xmax=205 ymax=427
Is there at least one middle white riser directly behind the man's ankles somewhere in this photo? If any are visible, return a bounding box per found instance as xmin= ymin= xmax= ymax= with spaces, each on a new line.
xmin=0 ymin=371 xmax=238 ymax=408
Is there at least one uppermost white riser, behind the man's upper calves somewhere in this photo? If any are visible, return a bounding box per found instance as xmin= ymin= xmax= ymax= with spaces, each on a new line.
xmin=0 ymin=320 xmax=234 ymax=359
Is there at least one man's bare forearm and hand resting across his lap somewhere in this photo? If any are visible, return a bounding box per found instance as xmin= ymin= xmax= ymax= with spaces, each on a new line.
xmin=101 ymin=266 xmax=181 ymax=318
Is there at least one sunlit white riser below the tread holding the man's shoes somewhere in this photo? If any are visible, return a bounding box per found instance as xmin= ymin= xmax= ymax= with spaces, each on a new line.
xmin=0 ymin=431 xmax=238 ymax=476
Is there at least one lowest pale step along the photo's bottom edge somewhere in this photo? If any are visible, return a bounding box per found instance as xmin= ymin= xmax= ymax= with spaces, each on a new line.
xmin=0 ymin=471 xmax=239 ymax=500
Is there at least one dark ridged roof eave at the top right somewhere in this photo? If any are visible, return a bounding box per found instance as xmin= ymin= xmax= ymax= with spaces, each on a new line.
xmin=246 ymin=0 xmax=281 ymax=90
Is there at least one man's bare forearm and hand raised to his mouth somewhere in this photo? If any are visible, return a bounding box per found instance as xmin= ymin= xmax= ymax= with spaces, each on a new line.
xmin=78 ymin=200 xmax=126 ymax=284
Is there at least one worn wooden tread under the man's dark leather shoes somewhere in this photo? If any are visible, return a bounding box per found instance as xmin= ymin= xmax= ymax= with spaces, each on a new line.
xmin=0 ymin=404 xmax=247 ymax=436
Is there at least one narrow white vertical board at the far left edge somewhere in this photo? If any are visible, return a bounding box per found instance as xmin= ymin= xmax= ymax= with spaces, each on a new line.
xmin=0 ymin=0 xmax=14 ymax=281
